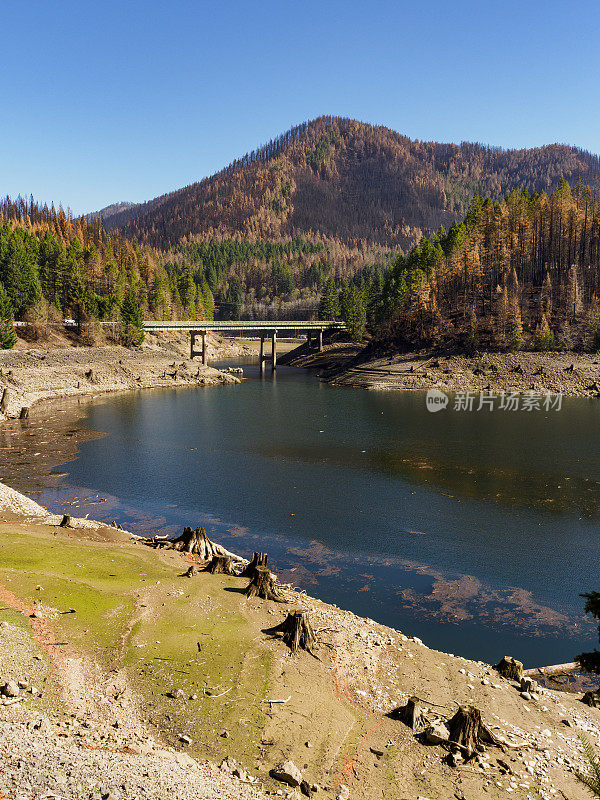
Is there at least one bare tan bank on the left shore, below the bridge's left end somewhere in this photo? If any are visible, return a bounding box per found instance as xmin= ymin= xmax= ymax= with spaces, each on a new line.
xmin=0 ymin=335 xmax=252 ymax=421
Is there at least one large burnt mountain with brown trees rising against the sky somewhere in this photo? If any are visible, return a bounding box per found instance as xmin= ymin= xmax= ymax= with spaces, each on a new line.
xmin=103 ymin=117 xmax=600 ymax=249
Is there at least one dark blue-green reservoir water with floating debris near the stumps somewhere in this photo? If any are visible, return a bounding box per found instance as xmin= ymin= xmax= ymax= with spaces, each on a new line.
xmin=36 ymin=360 xmax=600 ymax=666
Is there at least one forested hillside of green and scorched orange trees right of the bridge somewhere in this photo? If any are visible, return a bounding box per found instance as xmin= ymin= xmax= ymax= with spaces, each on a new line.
xmin=373 ymin=181 xmax=600 ymax=350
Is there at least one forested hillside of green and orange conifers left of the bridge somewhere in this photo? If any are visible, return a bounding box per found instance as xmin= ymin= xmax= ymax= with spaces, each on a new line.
xmin=0 ymin=198 xmax=213 ymax=332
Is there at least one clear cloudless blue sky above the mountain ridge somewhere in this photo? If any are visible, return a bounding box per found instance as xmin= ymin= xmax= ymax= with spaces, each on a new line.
xmin=0 ymin=0 xmax=600 ymax=213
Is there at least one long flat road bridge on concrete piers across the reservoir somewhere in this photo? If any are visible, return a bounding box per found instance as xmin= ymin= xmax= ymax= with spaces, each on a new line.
xmin=144 ymin=319 xmax=346 ymax=372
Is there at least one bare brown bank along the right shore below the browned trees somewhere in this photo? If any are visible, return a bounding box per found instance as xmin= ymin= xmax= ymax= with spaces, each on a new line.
xmin=286 ymin=344 xmax=600 ymax=397
